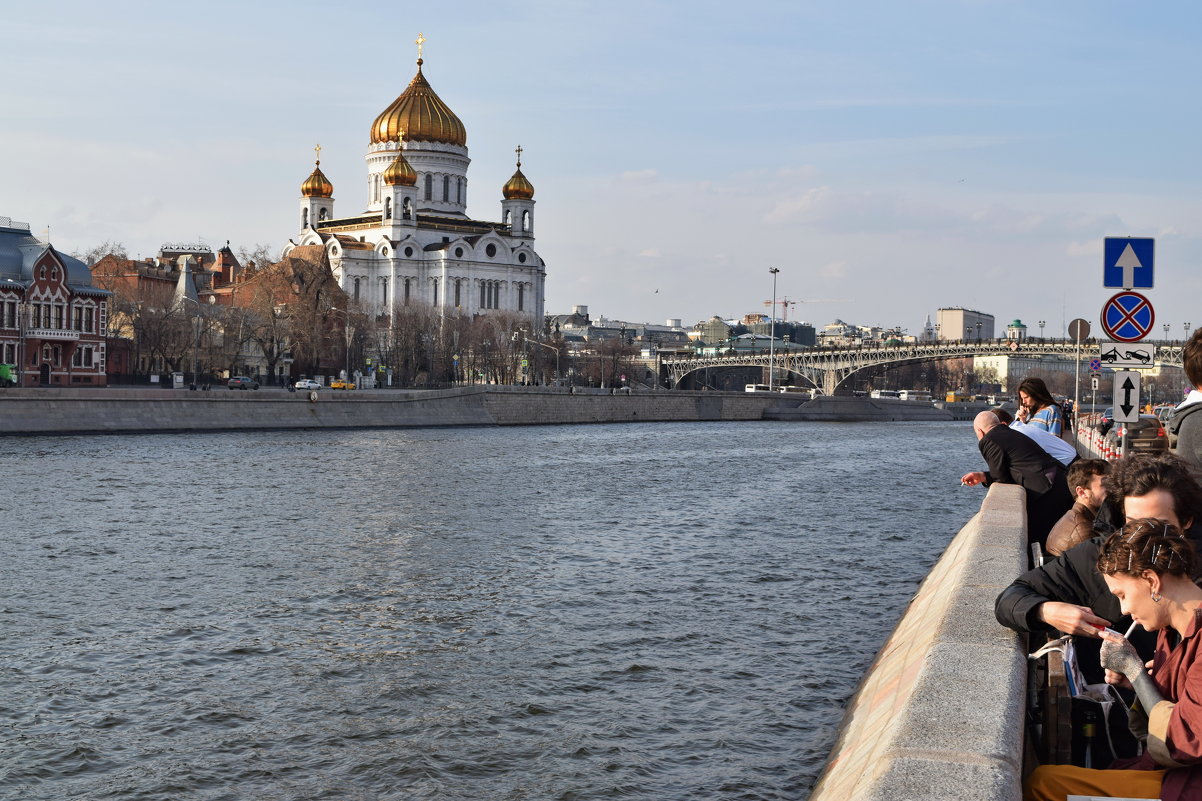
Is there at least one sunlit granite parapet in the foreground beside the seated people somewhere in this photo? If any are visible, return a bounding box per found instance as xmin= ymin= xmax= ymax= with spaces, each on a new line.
xmin=810 ymin=483 xmax=1027 ymax=801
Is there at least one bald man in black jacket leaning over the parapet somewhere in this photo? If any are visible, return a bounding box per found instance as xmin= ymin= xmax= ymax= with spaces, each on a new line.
xmin=960 ymin=411 xmax=1072 ymax=544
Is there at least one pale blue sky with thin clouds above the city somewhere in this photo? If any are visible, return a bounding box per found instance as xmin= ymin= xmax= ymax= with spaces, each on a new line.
xmin=0 ymin=0 xmax=1202 ymax=339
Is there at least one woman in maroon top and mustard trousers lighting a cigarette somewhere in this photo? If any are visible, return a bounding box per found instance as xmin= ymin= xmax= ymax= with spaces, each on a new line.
xmin=1024 ymin=517 xmax=1202 ymax=801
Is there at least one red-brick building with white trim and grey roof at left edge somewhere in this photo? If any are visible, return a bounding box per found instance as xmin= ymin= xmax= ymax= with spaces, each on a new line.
xmin=0 ymin=216 xmax=111 ymax=386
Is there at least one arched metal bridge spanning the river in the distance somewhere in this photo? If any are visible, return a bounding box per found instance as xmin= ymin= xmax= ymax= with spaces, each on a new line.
xmin=662 ymin=339 xmax=1182 ymax=394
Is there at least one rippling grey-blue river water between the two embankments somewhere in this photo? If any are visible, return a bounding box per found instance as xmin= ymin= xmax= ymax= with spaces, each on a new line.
xmin=0 ymin=422 xmax=983 ymax=801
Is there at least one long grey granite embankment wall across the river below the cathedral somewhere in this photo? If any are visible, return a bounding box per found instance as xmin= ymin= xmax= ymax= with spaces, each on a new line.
xmin=0 ymin=386 xmax=778 ymax=435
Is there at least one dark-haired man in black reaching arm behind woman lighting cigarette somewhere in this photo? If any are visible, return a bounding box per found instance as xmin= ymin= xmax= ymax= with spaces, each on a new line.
xmin=994 ymin=453 xmax=1202 ymax=637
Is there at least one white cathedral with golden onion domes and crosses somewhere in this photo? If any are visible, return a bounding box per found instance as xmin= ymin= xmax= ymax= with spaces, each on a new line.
xmin=282 ymin=36 xmax=547 ymax=330
